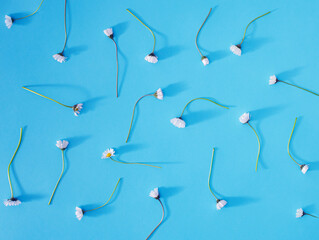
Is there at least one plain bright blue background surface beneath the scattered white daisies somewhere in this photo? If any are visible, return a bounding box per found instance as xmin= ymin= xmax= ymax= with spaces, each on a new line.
xmin=0 ymin=0 xmax=319 ymax=240
